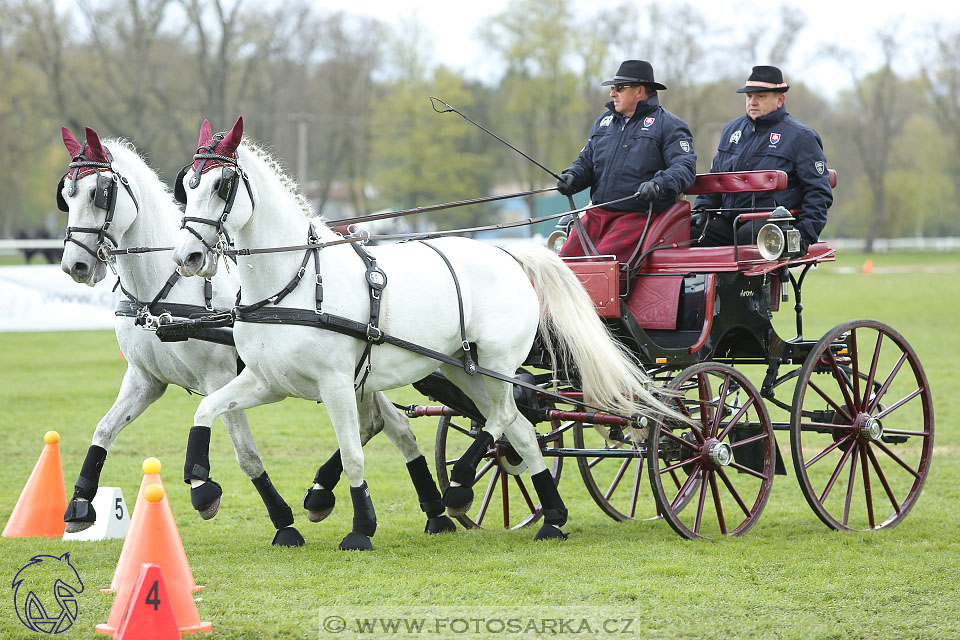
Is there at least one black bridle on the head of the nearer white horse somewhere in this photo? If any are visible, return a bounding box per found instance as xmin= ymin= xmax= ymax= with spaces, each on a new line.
xmin=174 ymin=133 xmax=255 ymax=260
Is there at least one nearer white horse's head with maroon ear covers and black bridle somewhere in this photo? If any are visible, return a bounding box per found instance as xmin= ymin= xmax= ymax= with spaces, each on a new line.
xmin=173 ymin=116 xmax=253 ymax=277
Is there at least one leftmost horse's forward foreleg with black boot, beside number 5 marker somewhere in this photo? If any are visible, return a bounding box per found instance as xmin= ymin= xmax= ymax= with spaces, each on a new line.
xmin=63 ymin=366 xmax=167 ymax=533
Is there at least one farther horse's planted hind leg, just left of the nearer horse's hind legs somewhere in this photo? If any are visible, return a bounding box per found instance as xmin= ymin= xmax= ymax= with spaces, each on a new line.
xmin=370 ymin=393 xmax=457 ymax=534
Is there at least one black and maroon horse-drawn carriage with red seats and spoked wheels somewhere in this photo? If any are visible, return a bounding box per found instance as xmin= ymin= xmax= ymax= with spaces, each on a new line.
xmin=407 ymin=171 xmax=933 ymax=538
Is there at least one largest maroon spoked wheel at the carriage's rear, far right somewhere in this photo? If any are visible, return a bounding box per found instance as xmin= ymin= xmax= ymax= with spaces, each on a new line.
xmin=790 ymin=320 xmax=933 ymax=531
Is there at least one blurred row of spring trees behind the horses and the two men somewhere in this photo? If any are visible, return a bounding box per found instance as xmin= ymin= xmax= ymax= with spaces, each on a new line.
xmin=0 ymin=0 xmax=960 ymax=250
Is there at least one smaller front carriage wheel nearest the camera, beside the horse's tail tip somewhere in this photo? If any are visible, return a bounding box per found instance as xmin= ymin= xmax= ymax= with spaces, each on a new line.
xmin=647 ymin=362 xmax=775 ymax=539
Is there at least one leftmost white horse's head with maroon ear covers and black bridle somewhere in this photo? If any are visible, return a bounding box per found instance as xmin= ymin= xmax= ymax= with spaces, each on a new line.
xmin=57 ymin=127 xmax=139 ymax=286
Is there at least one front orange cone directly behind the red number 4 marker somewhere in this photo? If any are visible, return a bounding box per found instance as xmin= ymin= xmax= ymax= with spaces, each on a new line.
xmin=97 ymin=484 xmax=212 ymax=635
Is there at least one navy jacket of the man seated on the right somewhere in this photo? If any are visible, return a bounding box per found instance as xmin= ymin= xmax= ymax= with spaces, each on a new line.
xmin=694 ymin=107 xmax=833 ymax=243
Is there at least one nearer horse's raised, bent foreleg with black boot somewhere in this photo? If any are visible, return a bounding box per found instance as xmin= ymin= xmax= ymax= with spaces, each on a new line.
xmin=183 ymin=368 xmax=284 ymax=520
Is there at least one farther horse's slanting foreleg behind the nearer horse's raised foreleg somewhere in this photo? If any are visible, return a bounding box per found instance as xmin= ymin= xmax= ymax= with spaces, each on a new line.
xmin=221 ymin=411 xmax=304 ymax=547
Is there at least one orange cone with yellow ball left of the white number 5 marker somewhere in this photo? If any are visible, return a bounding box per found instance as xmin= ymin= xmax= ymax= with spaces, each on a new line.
xmin=3 ymin=431 xmax=67 ymax=538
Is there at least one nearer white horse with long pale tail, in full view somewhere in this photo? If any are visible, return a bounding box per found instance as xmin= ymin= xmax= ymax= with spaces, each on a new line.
xmin=174 ymin=118 xmax=684 ymax=549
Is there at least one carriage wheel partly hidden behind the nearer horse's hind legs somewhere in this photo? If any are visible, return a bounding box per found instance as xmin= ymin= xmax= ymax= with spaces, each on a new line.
xmin=435 ymin=416 xmax=563 ymax=529
